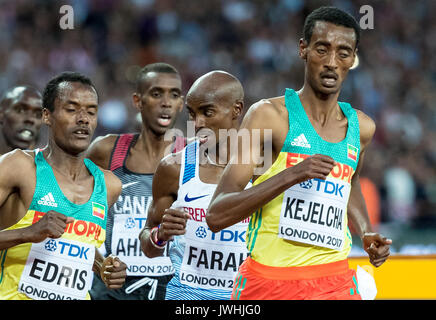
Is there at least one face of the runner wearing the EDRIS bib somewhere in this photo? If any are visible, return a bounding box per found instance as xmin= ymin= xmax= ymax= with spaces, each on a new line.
xmin=44 ymin=82 xmax=98 ymax=154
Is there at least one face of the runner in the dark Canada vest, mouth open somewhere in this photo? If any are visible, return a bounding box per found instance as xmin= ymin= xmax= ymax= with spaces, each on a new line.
xmin=133 ymin=72 xmax=183 ymax=135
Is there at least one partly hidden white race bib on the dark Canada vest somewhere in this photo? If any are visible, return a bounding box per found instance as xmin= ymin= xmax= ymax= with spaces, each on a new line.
xmin=112 ymin=197 xmax=174 ymax=276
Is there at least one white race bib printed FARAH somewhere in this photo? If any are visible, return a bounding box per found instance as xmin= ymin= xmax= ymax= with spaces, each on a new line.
xmin=180 ymin=219 xmax=248 ymax=291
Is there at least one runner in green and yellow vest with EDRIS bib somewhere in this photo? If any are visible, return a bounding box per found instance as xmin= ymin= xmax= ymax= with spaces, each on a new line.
xmin=0 ymin=72 xmax=126 ymax=300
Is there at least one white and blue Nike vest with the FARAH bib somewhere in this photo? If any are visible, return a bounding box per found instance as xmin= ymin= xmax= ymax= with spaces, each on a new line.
xmin=165 ymin=141 xmax=248 ymax=300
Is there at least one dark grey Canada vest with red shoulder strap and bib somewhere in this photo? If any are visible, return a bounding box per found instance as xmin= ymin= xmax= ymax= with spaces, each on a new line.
xmin=91 ymin=133 xmax=185 ymax=300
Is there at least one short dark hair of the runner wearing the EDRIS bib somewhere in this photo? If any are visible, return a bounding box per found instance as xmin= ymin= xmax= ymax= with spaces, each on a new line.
xmin=42 ymin=71 xmax=98 ymax=112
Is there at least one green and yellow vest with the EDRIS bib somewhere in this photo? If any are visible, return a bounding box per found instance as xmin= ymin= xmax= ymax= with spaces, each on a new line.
xmin=0 ymin=150 xmax=108 ymax=300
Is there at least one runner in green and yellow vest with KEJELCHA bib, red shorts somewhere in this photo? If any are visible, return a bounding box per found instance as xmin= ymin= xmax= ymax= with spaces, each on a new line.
xmin=207 ymin=7 xmax=391 ymax=300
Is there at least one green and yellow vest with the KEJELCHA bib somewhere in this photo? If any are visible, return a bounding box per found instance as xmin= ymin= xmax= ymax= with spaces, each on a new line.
xmin=247 ymin=89 xmax=360 ymax=267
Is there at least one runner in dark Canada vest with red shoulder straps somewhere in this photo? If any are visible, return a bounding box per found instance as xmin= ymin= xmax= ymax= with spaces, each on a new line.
xmin=89 ymin=63 xmax=184 ymax=300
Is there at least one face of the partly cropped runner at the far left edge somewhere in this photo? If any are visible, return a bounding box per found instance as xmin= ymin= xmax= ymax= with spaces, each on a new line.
xmin=2 ymin=91 xmax=42 ymax=149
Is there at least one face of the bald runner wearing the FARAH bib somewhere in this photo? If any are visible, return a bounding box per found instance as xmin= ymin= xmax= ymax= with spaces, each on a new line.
xmin=186 ymin=90 xmax=235 ymax=143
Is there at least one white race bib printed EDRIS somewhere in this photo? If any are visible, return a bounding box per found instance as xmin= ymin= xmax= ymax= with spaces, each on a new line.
xmin=18 ymin=238 xmax=95 ymax=300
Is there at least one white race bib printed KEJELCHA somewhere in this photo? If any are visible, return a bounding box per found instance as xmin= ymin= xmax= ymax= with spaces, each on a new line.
xmin=278 ymin=177 xmax=350 ymax=251
